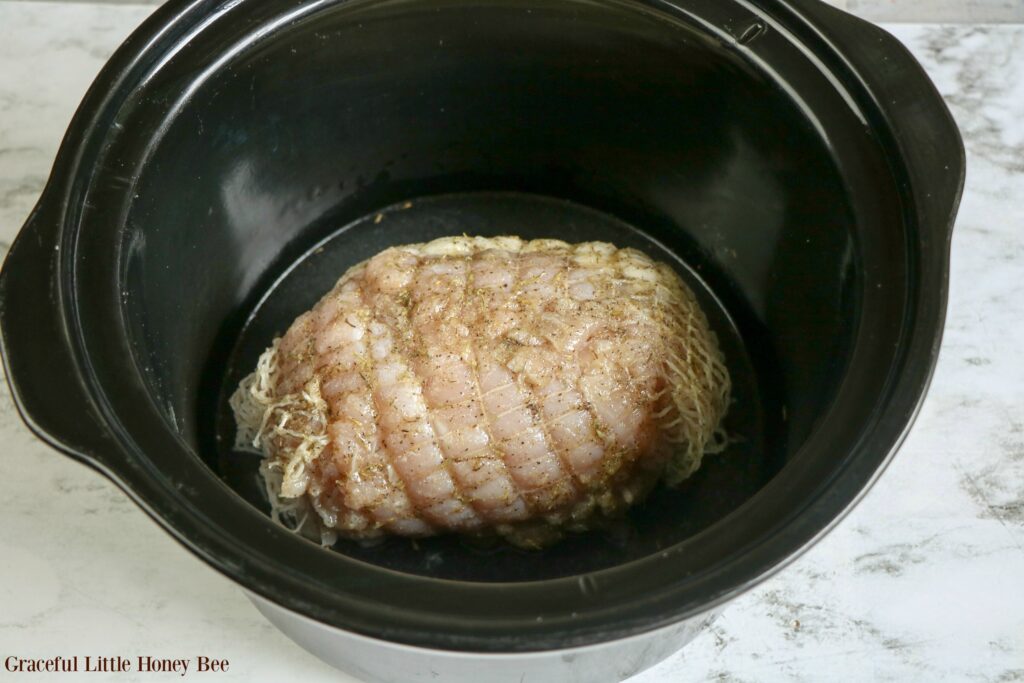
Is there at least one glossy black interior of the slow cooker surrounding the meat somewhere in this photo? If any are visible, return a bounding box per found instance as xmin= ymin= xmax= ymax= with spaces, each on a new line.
xmin=112 ymin=0 xmax=865 ymax=581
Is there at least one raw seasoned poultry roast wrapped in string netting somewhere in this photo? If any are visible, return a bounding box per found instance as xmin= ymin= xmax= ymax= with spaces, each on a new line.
xmin=232 ymin=238 xmax=729 ymax=547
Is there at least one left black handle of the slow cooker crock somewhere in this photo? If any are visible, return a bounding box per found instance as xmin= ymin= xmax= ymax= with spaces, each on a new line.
xmin=0 ymin=200 xmax=115 ymax=470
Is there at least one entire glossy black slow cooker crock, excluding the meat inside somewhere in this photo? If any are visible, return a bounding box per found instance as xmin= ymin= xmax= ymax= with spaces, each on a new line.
xmin=0 ymin=0 xmax=964 ymax=650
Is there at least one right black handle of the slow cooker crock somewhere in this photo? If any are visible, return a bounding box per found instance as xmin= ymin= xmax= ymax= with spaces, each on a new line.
xmin=785 ymin=0 xmax=967 ymax=232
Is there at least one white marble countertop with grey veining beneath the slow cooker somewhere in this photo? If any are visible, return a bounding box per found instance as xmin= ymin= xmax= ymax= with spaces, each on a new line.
xmin=0 ymin=1 xmax=1024 ymax=683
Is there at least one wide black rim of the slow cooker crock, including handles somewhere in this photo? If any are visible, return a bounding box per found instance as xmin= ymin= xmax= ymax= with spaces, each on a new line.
xmin=0 ymin=0 xmax=965 ymax=652
